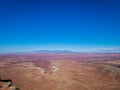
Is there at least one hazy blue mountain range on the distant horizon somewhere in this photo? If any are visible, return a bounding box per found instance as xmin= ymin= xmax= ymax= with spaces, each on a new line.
xmin=35 ymin=50 xmax=74 ymax=53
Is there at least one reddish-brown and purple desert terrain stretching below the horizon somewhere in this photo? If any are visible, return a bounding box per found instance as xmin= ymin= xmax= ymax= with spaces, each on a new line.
xmin=0 ymin=53 xmax=120 ymax=90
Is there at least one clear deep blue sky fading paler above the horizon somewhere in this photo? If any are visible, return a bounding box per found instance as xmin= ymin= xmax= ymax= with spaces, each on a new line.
xmin=0 ymin=0 xmax=120 ymax=52
